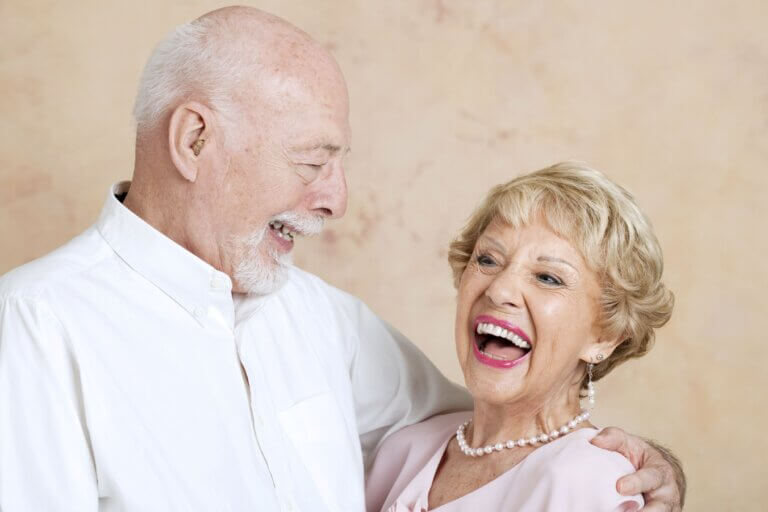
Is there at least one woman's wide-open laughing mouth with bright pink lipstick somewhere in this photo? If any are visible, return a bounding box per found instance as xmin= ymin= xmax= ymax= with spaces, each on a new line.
xmin=473 ymin=316 xmax=532 ymax=368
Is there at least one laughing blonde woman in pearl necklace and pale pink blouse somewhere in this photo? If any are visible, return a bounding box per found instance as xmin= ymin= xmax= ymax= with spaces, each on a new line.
xmin=367 ymin=162 xmax=673 ymax=512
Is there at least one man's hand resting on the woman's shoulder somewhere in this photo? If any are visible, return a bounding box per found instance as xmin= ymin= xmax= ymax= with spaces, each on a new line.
xmin=592 ymin=427 xmax=685 ymax=512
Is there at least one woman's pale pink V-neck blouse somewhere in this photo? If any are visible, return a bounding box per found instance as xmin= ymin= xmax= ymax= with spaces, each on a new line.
xmin=365 ymin=412 xmax=643 ymax=512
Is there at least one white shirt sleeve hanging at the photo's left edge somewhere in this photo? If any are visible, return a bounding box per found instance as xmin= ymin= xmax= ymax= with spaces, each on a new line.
xmin=0 ymin=297 xmax=98 ymax=512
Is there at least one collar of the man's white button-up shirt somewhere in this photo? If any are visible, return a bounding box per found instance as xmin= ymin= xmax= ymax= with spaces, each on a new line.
xmin=96 ymin=181 xmax=232 ymax=317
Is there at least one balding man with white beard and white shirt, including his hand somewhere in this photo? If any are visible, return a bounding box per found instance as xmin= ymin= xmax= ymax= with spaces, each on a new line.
xmin=0 ymin=7 xmax=679 ymax=512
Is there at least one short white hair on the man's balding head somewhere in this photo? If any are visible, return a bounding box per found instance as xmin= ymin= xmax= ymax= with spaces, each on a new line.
xmin=133 ymin=17 xmax=249 ymax=131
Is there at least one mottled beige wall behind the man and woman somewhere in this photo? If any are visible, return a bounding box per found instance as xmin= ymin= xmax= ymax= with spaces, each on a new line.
xmin=0 ymin=0 xmax=768 ymax=511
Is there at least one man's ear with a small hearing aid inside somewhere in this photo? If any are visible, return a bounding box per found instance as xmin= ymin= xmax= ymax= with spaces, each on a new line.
xmin=168 ymin=102 xmax=213 ymax=182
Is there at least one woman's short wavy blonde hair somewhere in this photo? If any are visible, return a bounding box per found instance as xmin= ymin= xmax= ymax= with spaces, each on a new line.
xmin=448 ymin=162 xmax=674 ymax=380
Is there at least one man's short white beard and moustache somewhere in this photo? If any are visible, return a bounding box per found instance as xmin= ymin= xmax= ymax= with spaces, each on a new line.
xmin=234 ymin=212 xmax=325 ymax=295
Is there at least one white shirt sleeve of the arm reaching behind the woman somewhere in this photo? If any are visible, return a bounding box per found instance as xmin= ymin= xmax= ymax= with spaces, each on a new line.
xmin=344 ymin=302 xmax=472 ymax=469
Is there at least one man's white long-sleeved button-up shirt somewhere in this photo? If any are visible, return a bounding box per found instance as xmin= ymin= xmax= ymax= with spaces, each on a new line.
xmin=0 ymin=183 xmax=471 ymax=512
